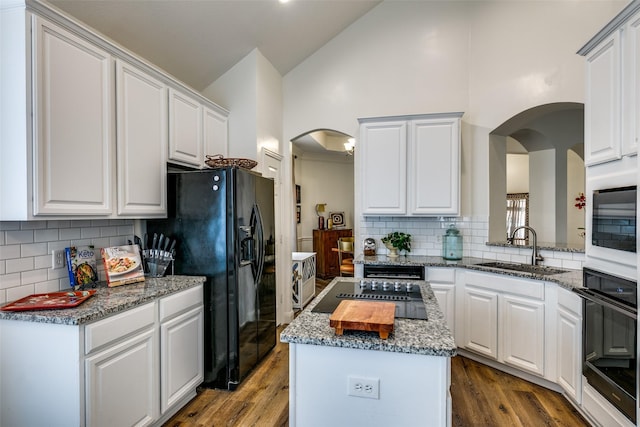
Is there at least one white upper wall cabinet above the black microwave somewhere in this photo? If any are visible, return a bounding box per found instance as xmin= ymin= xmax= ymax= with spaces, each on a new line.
xmin=578 ymin=2 xmax=640 ymax=166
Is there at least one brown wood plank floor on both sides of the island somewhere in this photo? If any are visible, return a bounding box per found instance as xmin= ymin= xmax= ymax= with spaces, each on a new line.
xmin=164 ymin=283 xmax=589 ymax=427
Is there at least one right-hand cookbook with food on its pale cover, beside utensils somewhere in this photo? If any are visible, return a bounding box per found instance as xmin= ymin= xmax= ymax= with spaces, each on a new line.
xmin=101 ymin=245 xmax=144 ymax=287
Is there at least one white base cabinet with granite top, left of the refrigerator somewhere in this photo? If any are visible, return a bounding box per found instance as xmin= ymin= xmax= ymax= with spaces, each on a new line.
xmin=0 ymin=276 xmax=205 ymax=427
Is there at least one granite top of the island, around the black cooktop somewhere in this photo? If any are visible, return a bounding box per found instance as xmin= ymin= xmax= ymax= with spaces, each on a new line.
xmin=280 ymin=277 xmax=456 ymax=357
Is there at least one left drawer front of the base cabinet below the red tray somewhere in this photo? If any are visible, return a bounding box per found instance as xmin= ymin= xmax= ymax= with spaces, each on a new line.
xmin=85 ymin=303 xmax=156 ymax=354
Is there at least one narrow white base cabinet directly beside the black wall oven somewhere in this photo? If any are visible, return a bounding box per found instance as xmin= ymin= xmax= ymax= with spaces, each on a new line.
xmin=555 ymin=287 xmax=582 ymax=404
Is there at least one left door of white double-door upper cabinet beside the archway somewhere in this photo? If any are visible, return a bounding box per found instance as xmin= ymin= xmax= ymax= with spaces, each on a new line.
xmin=358 ymin=121 xmax=407 ymax=215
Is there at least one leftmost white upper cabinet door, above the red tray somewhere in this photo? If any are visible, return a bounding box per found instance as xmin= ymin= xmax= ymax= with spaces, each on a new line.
xmin=33 ymin=17 xmax=115 ymax=216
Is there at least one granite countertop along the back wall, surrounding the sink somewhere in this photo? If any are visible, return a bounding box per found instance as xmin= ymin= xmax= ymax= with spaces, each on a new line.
xmin=353 ymin=255 xmax=583 ymax=290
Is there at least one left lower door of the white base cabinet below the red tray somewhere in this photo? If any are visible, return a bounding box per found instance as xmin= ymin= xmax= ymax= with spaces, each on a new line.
xmin=85 ymin=329 xmax=159 ymax=427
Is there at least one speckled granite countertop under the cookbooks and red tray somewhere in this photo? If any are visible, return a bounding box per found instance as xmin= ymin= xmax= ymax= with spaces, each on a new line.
xmin=0 ymin=276 xmax=206 ymax=325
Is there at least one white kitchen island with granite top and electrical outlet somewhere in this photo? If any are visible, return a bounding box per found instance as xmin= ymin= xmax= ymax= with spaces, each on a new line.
xmin=280 ymin=277 xmax=456 ymax=427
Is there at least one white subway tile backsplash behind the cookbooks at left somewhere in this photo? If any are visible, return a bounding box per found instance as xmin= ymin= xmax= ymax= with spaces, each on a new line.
xmin=0 ymin=220 xmax=134 ymax=303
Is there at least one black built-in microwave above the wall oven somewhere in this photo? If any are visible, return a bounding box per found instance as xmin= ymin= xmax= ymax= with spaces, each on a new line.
xmin=591 ymin=186 xmax=637 ymax=252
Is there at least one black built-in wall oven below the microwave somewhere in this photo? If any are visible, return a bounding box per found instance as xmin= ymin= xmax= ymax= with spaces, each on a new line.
xmin=574 ymin=268 xmax=638 ymax=423
